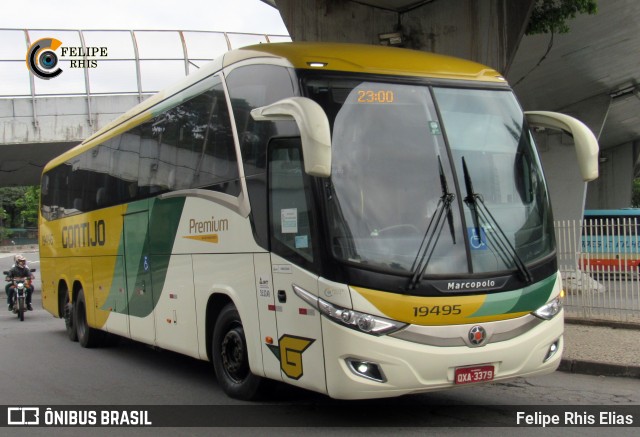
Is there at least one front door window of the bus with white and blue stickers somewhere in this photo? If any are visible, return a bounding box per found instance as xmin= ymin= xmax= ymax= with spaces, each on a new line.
xmin=269 ymin=138 xmax=316 ymax=267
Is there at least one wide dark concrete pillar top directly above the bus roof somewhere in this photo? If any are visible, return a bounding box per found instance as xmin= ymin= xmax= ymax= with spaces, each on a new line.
xmin=276 ymin=0 xmax=534 ymax=74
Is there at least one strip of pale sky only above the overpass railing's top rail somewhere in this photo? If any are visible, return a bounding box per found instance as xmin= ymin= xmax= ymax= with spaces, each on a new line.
xmin=0 ymin=0 xmax=287 ymax=35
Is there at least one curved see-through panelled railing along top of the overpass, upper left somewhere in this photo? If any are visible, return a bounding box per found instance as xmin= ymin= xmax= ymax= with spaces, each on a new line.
xmin=0 ymin=28 xmax=291 ymax=100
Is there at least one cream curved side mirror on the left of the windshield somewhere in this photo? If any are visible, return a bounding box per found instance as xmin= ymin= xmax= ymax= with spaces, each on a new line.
xmin=251 ymin=97 xmax=331 ymax=178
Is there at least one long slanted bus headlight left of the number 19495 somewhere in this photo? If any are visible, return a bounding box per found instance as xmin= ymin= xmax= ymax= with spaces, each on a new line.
xmin=293 ymin=284 xmax=407 ymax=336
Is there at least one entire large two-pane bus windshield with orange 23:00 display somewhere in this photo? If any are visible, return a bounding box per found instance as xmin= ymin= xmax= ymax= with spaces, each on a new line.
xmin=303 ymin=77 xmax=555 ymax=276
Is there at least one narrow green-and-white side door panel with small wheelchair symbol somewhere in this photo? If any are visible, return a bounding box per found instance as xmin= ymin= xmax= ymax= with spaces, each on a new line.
xmin=124 ymin=201 xmax=155 ymax=344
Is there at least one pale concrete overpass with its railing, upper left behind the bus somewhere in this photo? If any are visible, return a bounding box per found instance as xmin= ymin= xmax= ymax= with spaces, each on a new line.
xmin=0 ymin=29 xmax=291 ymax=186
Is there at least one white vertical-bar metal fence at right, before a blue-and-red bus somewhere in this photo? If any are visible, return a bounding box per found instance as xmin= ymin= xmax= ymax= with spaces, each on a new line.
xmin=555 ymin=218 xmax=640 ymax=323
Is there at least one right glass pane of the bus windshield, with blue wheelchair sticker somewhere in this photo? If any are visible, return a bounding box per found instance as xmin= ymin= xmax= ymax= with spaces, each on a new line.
xmin=434 ymin=88 xmax=555 ymax=272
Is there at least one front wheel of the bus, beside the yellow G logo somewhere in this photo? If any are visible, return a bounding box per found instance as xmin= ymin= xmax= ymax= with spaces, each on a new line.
xmin=211 ymin=304 xmax=263 ymax=401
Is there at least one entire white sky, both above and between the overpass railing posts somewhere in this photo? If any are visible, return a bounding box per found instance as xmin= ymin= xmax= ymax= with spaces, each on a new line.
xmin=0 ymin=0 xmax=290 ymax=97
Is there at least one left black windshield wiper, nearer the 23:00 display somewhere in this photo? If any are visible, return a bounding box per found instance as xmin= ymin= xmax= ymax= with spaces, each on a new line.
xmin=407 ymin=156 xmax=456 ymax=290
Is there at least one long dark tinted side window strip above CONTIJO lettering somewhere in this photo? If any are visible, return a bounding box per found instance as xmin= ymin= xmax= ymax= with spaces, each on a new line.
xmin=42 ymin=78 xmax=240 ymax=219
